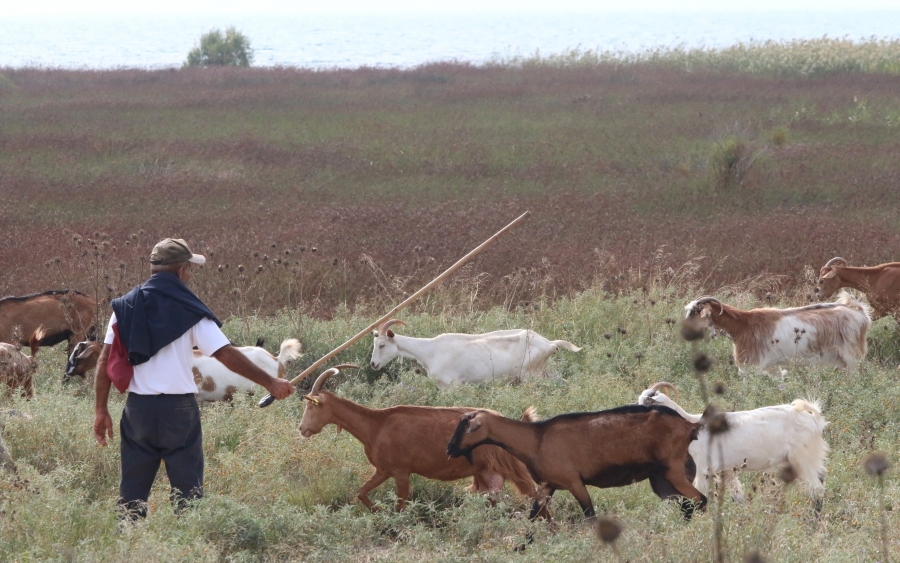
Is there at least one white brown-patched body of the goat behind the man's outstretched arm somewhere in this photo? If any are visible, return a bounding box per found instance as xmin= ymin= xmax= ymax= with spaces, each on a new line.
xmin=191 ymin=338 xmax=302 ymax=403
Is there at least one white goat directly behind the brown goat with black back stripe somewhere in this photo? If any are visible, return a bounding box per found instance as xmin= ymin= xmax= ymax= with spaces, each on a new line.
xmin=638 ymin=381 xmax=829 ymax=510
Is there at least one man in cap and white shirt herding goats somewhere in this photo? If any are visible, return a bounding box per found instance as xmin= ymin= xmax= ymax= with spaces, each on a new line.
xmin=94 ymin=238 xmax=294 ymax=518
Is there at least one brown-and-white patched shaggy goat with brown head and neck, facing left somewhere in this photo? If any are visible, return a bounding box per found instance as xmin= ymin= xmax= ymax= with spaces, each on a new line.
xmin=684 ymin=291 xmax=872 ymax=373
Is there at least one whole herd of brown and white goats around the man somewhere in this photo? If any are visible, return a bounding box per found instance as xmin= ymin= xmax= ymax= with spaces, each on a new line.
xmin=0 ymin=258 xmax=900 ymax=528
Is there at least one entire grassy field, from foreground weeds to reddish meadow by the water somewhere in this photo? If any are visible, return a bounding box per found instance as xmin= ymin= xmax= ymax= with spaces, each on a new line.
xmin=0 ymin=40 xmax=900 ymax=563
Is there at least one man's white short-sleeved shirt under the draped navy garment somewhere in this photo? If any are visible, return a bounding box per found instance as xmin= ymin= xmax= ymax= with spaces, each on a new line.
xmin=103 ymin=313 xmax=229 ymax=395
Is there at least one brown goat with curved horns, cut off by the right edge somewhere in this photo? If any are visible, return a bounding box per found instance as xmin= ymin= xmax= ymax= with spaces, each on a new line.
xmin=815 ymin=257 xmax=900 ymax=322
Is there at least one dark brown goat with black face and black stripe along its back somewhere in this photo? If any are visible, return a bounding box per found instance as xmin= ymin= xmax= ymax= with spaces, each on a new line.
xmin=447 ymin=405 xmax=706 ymax=519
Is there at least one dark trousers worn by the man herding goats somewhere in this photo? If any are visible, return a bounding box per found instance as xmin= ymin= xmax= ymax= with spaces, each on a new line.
xmin=119 ymin=393 xmax=203 ymax=517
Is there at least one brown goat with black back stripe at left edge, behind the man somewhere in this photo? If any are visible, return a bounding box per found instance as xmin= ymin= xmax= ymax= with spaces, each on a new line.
xmin=0 ymin=289 xmax=97 ymax=354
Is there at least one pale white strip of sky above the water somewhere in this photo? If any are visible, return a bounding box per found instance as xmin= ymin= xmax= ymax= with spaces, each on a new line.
xmin=7 ymin=0 xmax=900 ymax=17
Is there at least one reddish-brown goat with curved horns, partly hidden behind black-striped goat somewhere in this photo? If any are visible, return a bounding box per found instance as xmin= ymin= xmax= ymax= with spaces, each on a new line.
xmin=300 ymin=365 xmax=549 ymax=517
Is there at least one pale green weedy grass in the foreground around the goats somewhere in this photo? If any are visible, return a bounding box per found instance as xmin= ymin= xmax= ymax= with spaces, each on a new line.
xmin=0 ymin=283 xmax=900 ymax=563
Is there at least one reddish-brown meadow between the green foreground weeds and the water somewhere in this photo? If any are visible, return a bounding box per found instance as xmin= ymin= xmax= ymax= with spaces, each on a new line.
xmin=0 ymin=64 xmax=900 ymax=315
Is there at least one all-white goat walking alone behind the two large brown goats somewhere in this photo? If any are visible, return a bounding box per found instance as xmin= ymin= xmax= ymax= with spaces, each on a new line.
xmin=372 ymin=319 xmax=581 ymax=389
